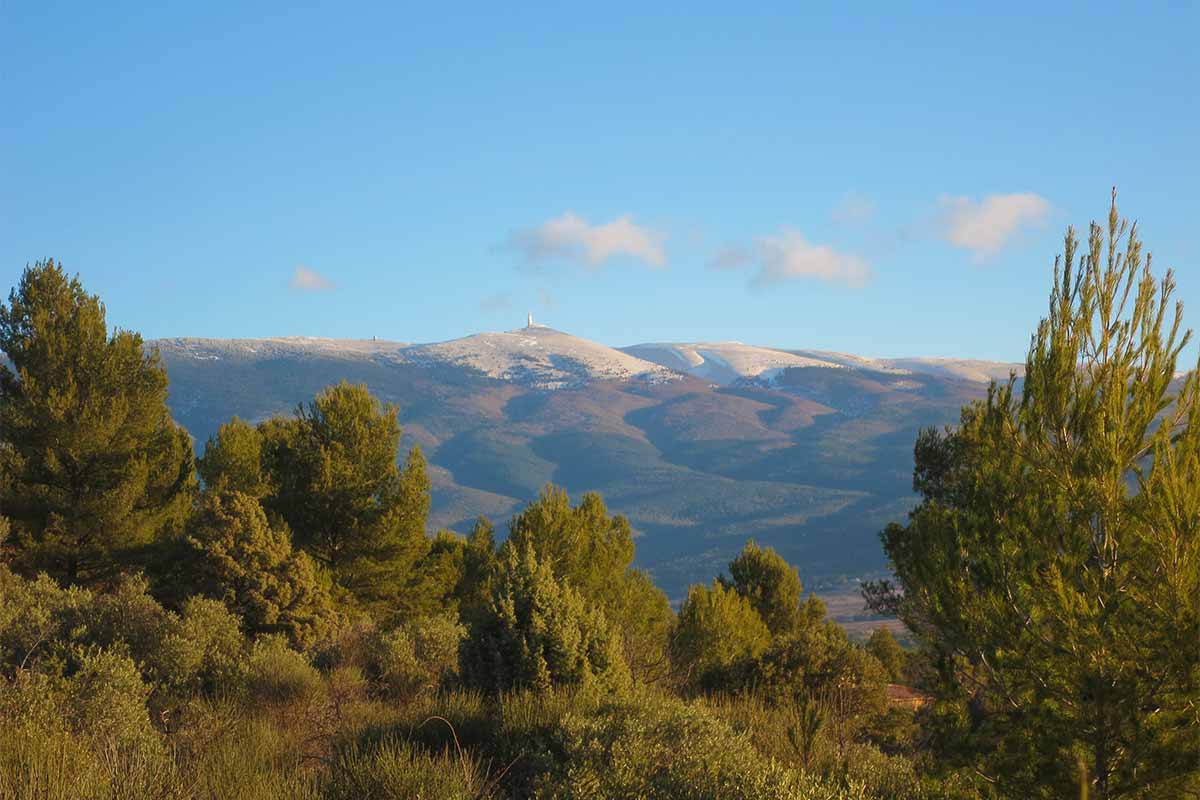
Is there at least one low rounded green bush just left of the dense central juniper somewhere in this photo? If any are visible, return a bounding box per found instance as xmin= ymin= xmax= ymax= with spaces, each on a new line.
xmin=367 ymin=614 xmax=467 ymax=699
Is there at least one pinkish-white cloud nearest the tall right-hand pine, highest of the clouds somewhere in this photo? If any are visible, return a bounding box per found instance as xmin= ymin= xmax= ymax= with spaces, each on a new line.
xmin=941 ymin=192 xmax=1050 ymax=261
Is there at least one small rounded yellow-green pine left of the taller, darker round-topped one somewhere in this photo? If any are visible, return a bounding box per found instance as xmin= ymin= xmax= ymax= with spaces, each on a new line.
xmin=671 ymin=581 xmax=770 ymax=691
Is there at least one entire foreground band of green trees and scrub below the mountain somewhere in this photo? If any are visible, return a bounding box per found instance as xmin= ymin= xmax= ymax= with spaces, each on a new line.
xmin=0 ymin=195 xmax=1200 ymax=800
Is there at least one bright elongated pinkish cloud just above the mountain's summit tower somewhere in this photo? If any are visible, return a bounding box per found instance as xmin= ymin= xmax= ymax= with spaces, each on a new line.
xmin=509 ymin=211 xmax=667 ymax=267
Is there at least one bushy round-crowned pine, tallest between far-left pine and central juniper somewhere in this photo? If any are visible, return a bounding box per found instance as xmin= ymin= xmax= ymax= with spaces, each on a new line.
xmin=255 ymin=381 xmax=434 ymax=615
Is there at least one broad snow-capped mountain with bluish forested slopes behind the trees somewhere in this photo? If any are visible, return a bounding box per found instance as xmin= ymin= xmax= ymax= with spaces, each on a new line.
xmin=150 ymin=326 xmax=1012 ymax=596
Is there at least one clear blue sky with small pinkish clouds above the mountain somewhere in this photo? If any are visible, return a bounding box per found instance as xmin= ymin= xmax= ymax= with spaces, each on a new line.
xmin=0 ymin=0 xmax=1200 ymax=360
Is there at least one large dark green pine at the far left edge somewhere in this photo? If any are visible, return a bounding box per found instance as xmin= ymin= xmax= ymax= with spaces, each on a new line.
xmin=0 ymin=261 xmax=194 ymax=584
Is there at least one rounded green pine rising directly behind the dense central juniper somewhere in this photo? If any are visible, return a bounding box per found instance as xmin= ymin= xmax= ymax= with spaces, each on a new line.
xmin=506 ymin=486 xmax=672 ymax=679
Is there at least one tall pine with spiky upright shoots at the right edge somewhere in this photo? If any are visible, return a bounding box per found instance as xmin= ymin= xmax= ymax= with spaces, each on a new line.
xmin=869 ymin=197 xmax=1200 ymax=800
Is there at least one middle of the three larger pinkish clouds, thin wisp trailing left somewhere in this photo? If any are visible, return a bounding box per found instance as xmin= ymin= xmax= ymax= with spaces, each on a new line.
xmin=709 ymin=228 xmax=871 ymax=287
